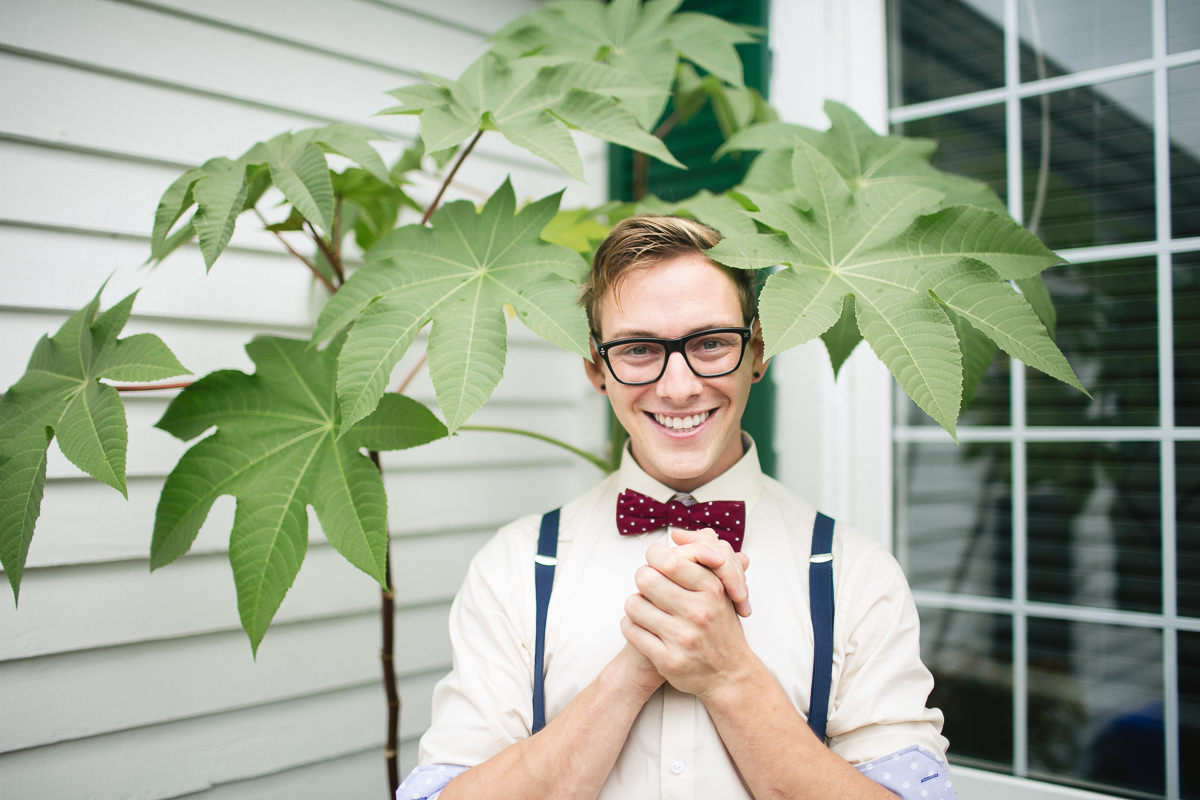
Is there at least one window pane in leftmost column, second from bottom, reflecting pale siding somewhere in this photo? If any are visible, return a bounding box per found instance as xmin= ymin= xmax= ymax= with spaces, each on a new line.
xmin=895 ymin=444 xmax=1013 ymax=597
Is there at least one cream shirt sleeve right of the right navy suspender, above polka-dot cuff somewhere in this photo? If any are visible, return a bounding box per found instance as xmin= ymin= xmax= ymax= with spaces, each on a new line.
xmin=828 ymin=534 xmax=947 ymax=764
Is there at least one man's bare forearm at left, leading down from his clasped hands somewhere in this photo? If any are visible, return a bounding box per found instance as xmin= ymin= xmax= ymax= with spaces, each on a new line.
xmin=440 ymin=652 xmax=655 ymax=800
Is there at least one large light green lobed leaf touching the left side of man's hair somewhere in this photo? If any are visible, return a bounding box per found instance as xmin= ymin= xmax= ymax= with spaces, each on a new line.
xmin=317 ymin=180 xmax=588 ymax=431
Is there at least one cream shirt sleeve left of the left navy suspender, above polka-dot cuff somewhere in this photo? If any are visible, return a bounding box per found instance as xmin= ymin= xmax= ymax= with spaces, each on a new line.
xmin=418 ymin=521 xmax=536 ymax=766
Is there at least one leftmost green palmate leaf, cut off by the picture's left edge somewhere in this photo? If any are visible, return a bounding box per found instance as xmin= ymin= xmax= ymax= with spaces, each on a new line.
xmin=0 ymin=293 xmax=187 ymax=599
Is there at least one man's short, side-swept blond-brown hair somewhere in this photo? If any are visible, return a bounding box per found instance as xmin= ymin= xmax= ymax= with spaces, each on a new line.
xmin=580 ymin=215 xmax=757 ymax=337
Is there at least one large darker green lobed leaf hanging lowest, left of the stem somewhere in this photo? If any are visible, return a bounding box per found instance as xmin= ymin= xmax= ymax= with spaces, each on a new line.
xmin=150 ymin=336 xmax=445 ymax=650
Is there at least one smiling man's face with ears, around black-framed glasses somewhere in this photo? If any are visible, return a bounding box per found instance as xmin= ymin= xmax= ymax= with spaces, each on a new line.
xmin=584 ymin=254 xmax=766 ymax=492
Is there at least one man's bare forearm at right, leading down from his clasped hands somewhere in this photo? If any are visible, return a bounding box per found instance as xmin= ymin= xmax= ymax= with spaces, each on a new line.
xmin=701 ymin=658 xmax=895 ymax=800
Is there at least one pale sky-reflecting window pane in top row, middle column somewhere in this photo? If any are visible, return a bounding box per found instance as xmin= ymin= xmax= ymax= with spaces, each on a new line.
xmin=1016 ymin=0 xmax=1152 ymax=83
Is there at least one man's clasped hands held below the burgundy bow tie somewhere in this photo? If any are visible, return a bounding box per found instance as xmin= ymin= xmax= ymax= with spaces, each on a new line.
xmin=620 ymin=529 xmax=750 ymax=700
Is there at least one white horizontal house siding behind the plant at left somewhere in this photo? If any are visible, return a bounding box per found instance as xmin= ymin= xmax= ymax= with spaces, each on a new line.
xmin=0 ymin=0 xmax=604 ymax=799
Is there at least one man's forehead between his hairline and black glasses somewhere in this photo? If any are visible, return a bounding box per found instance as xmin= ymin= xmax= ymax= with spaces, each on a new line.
xmin=598 ymin=253 xmax=744 ymax=339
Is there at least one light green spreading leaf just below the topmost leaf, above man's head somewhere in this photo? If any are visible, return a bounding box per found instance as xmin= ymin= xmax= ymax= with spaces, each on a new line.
xmin=384 ymin=53 xmax=683 ymax=180
